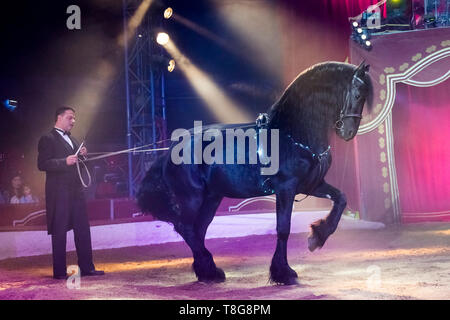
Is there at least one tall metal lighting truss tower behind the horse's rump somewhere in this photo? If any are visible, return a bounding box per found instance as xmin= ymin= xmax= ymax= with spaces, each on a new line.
xmin=123 ymin=0 xmax=166 ymax=197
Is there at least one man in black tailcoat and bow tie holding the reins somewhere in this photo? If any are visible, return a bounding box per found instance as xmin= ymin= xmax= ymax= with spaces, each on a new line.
xmin=38 ymin=107 xmax=104 ymax=279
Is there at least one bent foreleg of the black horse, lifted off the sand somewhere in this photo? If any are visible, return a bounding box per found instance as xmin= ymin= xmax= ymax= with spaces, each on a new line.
xmin=308 ymin=181 xmax=347 ymax=252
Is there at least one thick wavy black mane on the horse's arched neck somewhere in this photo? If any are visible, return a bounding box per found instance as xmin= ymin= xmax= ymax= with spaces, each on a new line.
xmin=269 ymin=62 xmax=372 ymax=142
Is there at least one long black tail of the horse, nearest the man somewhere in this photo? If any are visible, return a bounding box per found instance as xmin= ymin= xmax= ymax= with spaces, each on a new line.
xmin=136 ymin=158 xmax=177 ymax=222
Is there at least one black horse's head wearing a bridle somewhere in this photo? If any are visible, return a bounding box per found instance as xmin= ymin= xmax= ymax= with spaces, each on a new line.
xmin=335 ymin=61 xmax=372 ymax=141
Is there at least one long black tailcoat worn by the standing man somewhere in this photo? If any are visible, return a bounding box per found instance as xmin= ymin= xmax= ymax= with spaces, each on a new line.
xmin=37 ymin=129 xmax=85 ymax=234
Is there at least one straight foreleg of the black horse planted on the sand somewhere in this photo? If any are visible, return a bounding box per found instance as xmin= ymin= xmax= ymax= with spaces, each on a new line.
xmin=270 ymin=182 xmax=298 ymax=285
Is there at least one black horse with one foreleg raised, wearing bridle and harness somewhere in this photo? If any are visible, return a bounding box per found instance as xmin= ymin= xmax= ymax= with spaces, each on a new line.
xmin=137 ymin=62 xmax=372 ymax=284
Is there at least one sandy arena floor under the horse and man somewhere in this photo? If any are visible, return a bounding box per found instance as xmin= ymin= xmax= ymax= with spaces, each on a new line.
xmin=0 ymin=223 xmax=450 ymax=300
